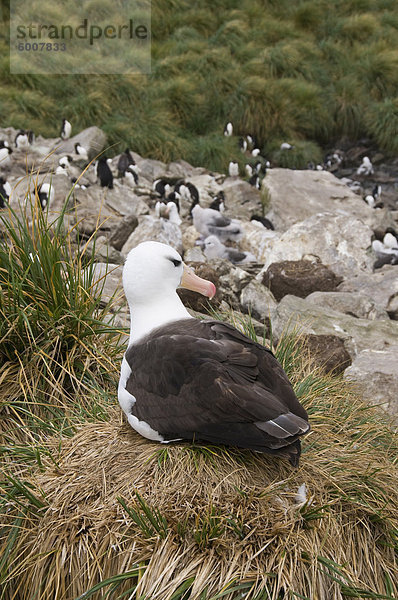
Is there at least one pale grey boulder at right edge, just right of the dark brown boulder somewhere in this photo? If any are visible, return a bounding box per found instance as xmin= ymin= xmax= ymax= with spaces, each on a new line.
xmin=339 ymin=265 xmax=398 ymax=320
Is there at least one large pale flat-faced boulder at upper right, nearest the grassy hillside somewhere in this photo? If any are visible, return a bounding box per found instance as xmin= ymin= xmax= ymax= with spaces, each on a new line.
xmin=263 ymin=169 xmax=375 ymax=231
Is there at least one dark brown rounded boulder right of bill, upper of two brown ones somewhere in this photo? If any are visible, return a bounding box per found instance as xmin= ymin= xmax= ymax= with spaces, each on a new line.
xmin=262 ymin=259 xmax=342 ymax=301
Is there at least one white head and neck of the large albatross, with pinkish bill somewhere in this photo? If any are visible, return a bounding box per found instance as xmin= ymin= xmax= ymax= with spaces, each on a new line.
xmin=123 ymin=242 xmax=216 ymax=344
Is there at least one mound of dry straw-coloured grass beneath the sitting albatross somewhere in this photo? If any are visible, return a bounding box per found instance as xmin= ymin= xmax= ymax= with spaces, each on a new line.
xmin=5 ymin=393 xmax=398 ymax=600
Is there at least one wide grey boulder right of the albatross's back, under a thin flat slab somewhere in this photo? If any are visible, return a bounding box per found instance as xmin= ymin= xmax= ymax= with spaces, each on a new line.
xmin=271 ymin=296 xmax=398 ymax=358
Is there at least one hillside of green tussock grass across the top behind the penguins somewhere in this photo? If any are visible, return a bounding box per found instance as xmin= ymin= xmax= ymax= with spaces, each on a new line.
xmin=0 ymin=0 xmax=398 ymax=169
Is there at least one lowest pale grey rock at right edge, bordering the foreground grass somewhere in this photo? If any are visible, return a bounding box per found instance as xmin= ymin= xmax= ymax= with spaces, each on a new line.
xmin=344 ymin=345 xmax=398 ymax=415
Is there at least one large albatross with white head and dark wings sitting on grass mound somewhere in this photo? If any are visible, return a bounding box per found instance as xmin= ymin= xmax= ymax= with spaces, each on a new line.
xmin=118 ymin=242 xmax=310 ymax=466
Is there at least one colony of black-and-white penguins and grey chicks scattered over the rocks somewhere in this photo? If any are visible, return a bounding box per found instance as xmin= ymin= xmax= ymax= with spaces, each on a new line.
xmin=0 ymin=118 xmax=398 ymax=268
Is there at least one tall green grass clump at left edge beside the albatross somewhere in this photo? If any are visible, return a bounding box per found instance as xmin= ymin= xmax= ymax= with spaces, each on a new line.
xmin=0 ymin=188 xmax=123 ymax=443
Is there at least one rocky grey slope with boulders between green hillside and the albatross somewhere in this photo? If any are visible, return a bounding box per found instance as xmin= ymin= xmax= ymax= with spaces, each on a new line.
xmin=0 ymin=127 xmax=398 ymax=411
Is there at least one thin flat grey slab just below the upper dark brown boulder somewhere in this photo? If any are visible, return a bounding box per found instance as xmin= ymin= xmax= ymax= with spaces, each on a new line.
xmin=306 ymin=292 xmax=389 ymax=321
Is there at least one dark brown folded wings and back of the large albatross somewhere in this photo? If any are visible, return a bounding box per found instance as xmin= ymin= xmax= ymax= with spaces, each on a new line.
xmin=126 ymin=319 xmax=309 ymax=464
